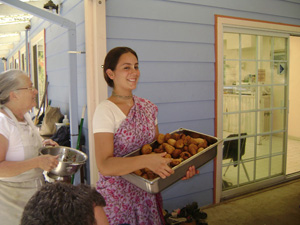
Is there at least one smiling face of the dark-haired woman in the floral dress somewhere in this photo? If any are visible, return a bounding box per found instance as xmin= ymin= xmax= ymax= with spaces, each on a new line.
xmin=107 ymin=52 xmax=140 ymax=91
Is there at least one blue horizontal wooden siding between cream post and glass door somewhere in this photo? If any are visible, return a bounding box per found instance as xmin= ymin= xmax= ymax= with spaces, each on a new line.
xmin=106 ymin=0 xmax=300 ymax=210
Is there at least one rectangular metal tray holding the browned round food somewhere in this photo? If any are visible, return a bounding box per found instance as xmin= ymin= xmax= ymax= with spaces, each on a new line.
xmin=122 ymin=128 xmax=221 ymax=194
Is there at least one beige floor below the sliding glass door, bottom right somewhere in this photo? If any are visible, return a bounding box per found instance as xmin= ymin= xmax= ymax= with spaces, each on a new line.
xmin=202 ymin=179 xmax=300 ymax=225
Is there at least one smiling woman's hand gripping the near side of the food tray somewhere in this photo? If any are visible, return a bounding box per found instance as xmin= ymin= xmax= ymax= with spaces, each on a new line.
xmin=147 ymin=152 xmax=174 ymax=179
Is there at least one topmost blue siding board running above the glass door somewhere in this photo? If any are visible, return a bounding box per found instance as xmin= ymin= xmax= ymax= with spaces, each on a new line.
xmin=107 ymin=0 xmax=300 ymax=24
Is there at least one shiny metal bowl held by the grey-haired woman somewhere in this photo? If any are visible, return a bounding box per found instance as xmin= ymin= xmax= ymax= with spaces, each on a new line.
xmin=39 ymin=146 xmax=88 ymax=176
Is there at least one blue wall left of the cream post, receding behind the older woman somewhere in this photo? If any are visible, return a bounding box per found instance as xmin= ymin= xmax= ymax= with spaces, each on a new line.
xmin=8 ymin=0 xmax=89 ymax=183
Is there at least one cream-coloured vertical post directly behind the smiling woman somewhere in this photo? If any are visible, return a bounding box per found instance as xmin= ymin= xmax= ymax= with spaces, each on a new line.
xmin=84 ymin=0 xmax=107 ymax=185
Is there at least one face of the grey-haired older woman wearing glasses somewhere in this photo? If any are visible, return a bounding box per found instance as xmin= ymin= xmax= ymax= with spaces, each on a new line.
xmin=18 ymin=75 xmax=38 ymax=110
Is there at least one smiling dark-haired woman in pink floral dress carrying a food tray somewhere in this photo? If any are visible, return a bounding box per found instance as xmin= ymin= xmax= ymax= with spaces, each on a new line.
xmin=93 ymin=47 xmax=197 ymax=225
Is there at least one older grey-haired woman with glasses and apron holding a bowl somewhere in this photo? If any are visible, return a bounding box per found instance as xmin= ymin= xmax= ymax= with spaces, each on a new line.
xmin=0 ymin=70 xmax=58 ymax=225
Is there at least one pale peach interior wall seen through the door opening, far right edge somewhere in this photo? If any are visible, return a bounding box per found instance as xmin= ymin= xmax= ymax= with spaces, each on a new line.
xmin=288 ymin=37 xmax=300 ymax=140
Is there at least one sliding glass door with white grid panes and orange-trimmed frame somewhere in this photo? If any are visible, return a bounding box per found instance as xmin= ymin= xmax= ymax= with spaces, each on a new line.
xmin=215 ymin=16 xmax=300 ymax=202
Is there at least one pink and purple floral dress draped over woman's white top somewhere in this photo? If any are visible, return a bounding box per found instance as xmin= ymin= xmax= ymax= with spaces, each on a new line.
xmin=97 ymin=96 xmax=164 ymax=225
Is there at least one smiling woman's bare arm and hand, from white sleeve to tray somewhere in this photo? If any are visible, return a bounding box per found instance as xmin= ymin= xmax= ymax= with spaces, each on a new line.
xmin=94 ymin=133 xmax=174 ymax=178
